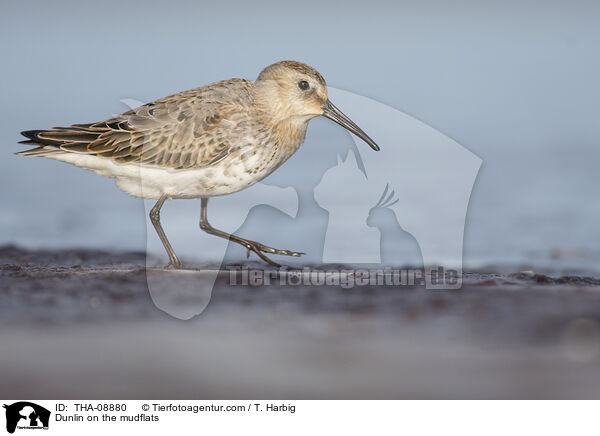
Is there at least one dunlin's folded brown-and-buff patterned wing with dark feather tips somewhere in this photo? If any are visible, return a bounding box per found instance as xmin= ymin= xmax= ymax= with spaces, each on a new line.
xmin=21 ymin=79 xmax=256 ymax=169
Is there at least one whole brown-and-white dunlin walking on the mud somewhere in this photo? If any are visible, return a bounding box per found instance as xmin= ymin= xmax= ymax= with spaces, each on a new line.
xmin=18 ymin=61 xmax=379 ymax=268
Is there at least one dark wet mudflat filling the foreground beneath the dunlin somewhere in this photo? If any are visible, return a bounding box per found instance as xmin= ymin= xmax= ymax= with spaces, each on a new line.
xmin=0 ymin=246 xmax=600 ymax=399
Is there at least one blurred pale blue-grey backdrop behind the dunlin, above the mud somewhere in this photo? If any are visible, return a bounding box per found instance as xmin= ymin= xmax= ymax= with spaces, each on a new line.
xmin=0 ymin=0 xmax=600 ymax=271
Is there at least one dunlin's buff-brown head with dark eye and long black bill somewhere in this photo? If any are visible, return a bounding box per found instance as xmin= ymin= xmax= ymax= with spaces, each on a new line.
xmin=255 ymin=61 xmax=379 ymax=150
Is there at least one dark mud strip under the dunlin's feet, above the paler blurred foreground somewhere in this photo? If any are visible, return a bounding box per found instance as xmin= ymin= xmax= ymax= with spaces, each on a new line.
xmin=0 ymin=246 xmax=600 ymax=326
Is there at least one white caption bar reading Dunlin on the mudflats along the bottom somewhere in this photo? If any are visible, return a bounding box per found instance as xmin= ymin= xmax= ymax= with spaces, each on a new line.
xmin=0 ymin=400 xmax=600 ymax=436
